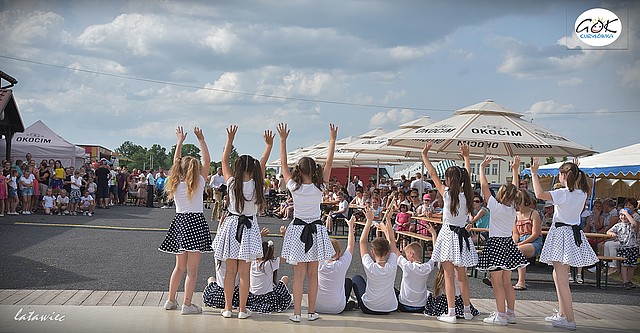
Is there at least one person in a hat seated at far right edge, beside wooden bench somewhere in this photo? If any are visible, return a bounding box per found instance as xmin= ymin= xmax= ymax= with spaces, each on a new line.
xmin=604 ymin=208 xmax=638 ymax=284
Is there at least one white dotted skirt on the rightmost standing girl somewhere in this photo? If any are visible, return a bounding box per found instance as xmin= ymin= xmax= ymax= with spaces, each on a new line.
xmin=540 ymin=227 xmax=598 ymax=267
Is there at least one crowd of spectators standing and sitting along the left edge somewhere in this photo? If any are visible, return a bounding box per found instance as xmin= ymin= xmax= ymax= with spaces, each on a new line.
xmin=0 ymin=153 xmax=171 ymax=216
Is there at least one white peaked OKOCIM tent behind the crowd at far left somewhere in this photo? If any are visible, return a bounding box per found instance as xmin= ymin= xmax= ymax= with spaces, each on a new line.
xmin=0 ymin=120 xmax=85 ymax=167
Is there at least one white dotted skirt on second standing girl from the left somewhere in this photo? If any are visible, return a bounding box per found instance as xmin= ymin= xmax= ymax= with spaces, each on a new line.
xmin=213 ymin=215 xmax=262 ymax=261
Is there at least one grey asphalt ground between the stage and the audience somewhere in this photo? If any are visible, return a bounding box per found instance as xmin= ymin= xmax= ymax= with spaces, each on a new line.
xmin=0 ymin=206 xmax=640 ymax=305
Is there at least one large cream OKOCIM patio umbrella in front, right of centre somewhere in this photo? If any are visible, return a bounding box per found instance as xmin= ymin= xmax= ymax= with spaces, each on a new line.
xmin=391 ymin=100 xmax=594 ymax=157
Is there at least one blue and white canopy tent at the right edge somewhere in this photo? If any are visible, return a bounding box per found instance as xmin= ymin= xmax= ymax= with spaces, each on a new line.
xmin=522 ymin=143 xmax=640 ymax=198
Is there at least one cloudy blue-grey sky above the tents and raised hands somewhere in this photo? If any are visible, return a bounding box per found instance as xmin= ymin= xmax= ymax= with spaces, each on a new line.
xmin=0 ymin=0 xmax=640 ymax=160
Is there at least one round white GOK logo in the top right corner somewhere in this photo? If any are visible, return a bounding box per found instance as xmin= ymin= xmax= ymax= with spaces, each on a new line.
xmin=575 ymin=8 xmax=622 ymax=47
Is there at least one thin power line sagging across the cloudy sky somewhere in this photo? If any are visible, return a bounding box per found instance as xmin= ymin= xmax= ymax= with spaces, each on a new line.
xmin=0 ymin=55 xmax=640 ymax=116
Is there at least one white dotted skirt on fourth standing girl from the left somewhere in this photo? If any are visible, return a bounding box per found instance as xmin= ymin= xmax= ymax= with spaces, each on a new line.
xmin=431 ymin=224 xmax=478 ymax=267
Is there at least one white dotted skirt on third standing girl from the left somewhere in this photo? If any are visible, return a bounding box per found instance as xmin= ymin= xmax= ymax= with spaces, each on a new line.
xmin=282 ymin=221 xmax=335 ymax=265
